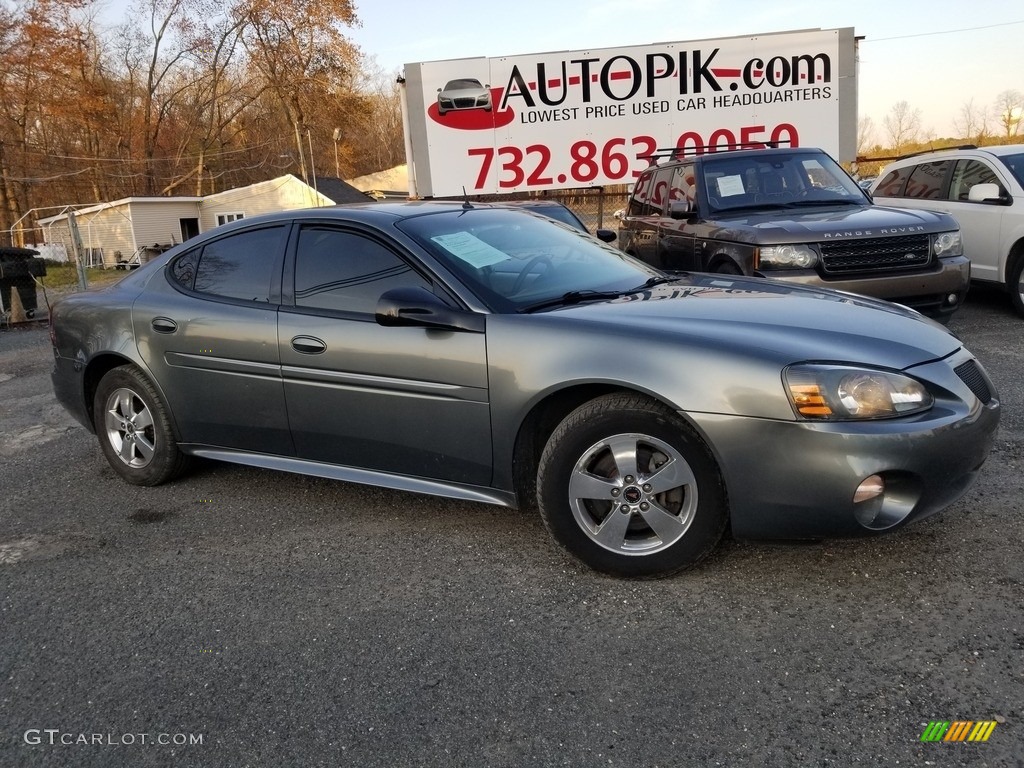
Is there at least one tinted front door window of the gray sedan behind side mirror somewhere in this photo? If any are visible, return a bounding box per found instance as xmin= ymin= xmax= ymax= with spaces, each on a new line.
xmin=295 ymin=226 xmax=432 ymax=314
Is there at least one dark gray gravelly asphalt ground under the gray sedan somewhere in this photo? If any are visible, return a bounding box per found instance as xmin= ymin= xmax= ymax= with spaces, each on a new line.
xmin=0 ymin=291 xmax=1024 ymax=768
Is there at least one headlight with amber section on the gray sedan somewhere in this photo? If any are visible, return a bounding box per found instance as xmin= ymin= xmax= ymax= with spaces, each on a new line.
xmin=782 ymin=365 xmax=933 ymax=421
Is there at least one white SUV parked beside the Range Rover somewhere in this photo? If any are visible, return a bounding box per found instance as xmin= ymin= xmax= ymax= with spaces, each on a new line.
xmin=871 ymin=144 xmax=1024 ymax=314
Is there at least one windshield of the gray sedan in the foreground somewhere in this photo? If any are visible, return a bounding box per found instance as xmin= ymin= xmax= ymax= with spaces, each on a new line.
xmin=398 ymin=208 xmax=660 ymax=312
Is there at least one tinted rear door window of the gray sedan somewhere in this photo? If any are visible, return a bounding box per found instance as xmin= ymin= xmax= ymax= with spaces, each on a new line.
xmin=195 ymin=226 xmax=287 ymax=301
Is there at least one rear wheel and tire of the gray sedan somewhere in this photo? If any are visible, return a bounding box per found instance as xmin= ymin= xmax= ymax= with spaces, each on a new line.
xmin=92 ymin=366 xmax=189 ymax=485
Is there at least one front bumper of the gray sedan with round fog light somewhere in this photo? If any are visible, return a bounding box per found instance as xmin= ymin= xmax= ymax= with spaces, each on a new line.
xmin=689 ymin=352 xmax=999 ymax=539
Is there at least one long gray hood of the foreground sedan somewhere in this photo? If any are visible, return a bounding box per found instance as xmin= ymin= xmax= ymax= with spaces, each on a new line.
xmin=552 ymin=273 xmax=962 ymax=370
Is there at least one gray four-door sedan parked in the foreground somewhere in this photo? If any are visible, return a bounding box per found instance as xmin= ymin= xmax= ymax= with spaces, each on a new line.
xmin=51 ymin=203 xmax=999 ymax=577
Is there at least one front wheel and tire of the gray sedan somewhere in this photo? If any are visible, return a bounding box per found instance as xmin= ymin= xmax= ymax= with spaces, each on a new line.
xmin=537 ymin=393 xmax=728 ymax=578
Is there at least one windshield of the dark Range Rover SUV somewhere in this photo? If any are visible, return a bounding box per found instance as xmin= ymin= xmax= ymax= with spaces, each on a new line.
xmin=702 ymin=152 xmax=868 ymax=212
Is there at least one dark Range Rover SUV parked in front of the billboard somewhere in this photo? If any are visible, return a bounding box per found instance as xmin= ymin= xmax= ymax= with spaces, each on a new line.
xmin=620 ymin=147 xmax=971 ymax=321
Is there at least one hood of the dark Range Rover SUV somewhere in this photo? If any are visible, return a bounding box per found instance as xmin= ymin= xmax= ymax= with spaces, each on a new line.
xmin=719 ymin=201 xmax=957 ymax=244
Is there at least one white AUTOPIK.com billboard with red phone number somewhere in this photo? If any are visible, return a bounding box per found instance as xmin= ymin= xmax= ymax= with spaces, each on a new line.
xmin=403 ymin=28 xmax=857 ymax=197
